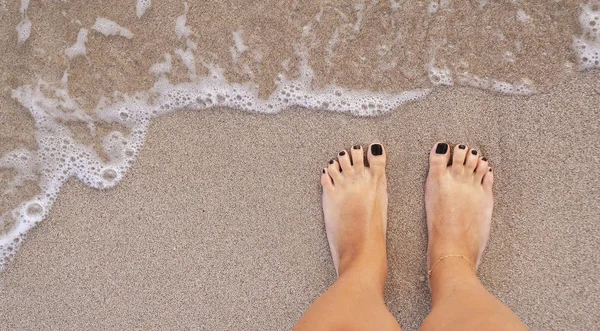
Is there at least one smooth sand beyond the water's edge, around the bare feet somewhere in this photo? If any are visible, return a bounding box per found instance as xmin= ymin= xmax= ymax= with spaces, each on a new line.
xmin=0 ymin=74 xmax=600 ymax=330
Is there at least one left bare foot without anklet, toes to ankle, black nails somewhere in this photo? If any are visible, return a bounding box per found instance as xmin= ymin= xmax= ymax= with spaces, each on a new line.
xmin=321 ymin=144 xmax=388 ymax=285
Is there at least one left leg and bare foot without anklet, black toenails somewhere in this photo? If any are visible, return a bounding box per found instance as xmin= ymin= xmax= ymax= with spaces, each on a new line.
xmin=294 ymin=144 xmax=400 ymax=330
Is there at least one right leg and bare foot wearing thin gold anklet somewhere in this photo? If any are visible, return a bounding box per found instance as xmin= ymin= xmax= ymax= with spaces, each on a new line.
xmin=422 ymin=143 xmax=527 ymax=330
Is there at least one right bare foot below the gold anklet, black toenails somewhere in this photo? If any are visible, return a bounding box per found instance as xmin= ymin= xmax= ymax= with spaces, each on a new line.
xmin=425 ymin=143 xmax=494 ymax=273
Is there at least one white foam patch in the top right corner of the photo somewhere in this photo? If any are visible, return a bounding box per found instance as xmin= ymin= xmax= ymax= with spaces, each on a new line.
xmin=573 ymin=0 xmax=600 ymax=70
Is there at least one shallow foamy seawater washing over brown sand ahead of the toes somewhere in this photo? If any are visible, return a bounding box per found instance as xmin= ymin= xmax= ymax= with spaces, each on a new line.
xmin=0 ymin=0 xmax=600 ymax=268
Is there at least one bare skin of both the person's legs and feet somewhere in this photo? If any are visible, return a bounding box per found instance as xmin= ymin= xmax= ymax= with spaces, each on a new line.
xmin=294 ymin=144 xmax=527 ymax=330
